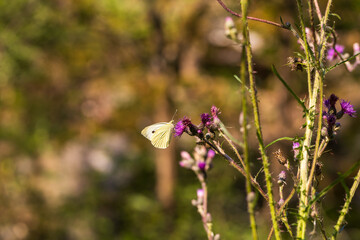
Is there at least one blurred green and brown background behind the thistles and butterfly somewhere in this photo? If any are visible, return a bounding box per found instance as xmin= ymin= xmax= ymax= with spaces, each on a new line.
xmin=0 ymin=0 xmax=360 ymax=240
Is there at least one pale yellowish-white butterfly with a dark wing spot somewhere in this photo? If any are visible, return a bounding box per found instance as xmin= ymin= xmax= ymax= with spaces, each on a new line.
xmin=141 ymin=120 xmax=174 ymax=149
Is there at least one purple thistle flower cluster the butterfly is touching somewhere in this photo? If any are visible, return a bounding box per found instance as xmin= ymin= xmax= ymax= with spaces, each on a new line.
xmin=174 ymin=106 xmax=220 ymax=138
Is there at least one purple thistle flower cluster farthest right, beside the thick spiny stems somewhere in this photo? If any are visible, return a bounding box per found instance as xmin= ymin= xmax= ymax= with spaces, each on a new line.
xmin=322 ymin=94 xmax=356 ymax=138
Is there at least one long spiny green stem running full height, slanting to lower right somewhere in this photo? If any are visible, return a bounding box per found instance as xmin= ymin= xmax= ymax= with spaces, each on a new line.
xmin=241 ymin=0 xmax=281 ymax=239
